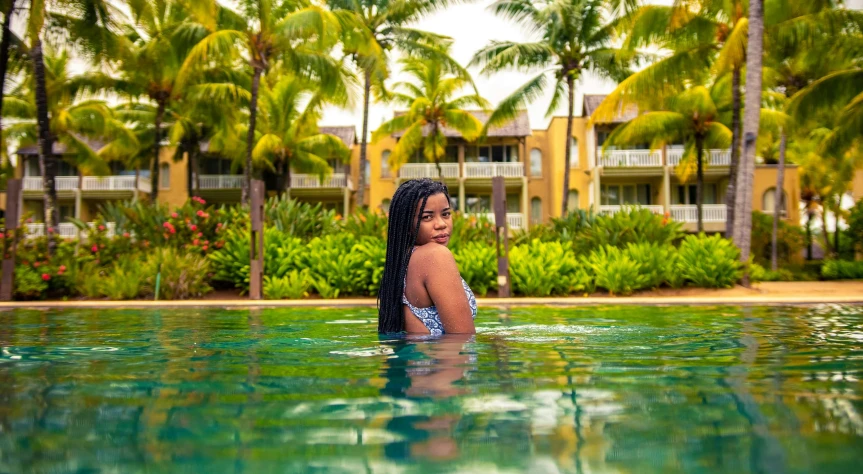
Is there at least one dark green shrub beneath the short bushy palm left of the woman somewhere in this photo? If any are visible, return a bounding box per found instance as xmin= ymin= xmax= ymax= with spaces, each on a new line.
xmin=264 ymin=196 xmax=339 ymax=240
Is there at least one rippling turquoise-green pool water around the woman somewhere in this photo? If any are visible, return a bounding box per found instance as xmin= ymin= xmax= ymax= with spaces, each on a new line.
xmin=0 ymin=305 xmax=863 ymax=473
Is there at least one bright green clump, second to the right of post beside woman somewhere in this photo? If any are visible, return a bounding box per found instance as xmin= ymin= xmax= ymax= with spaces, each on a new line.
xmin=584 ymin=245 xmax=650 ymax=295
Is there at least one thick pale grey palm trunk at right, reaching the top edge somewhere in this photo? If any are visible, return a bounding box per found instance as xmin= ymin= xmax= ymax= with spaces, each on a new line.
xmin=734 ymin=0 xmax=764 ymax=286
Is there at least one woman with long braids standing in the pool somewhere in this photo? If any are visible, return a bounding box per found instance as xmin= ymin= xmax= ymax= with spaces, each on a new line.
xmin=378 ymin=179 xmax=476 ymax=336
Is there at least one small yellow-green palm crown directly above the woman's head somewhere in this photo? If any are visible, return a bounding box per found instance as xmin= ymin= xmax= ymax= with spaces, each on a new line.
xmin=372 ymin=51 xmax=488 ymax=176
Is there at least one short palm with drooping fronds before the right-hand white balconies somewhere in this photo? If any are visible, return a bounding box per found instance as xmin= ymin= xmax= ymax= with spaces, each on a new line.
xmin=603 ymin=86 xmax=732 ymax=232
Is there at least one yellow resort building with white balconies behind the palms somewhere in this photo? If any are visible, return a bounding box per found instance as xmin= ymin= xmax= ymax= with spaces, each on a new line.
xmin=0 ymin=95 xmax=804 ymax=232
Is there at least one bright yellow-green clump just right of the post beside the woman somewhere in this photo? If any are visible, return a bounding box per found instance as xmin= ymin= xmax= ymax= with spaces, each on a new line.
xmin=509 ymin=240 xmax=592 ymax=296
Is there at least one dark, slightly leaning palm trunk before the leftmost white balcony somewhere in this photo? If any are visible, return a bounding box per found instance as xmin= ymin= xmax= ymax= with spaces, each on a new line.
xmin=30 ymin=37 xmax=59 ymax=255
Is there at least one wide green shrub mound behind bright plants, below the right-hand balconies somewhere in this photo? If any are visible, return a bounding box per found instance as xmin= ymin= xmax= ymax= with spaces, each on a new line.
xmin=572 ymin=208 xmax=683 ymax=254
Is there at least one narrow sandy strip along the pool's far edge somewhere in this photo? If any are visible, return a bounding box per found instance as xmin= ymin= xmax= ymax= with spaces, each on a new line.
xmin=0 ymin=281 xmax=863 ymax=309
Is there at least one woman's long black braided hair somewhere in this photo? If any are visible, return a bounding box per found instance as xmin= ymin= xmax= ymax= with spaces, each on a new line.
xmin=378 ymin=179 xmax=450 ymax=333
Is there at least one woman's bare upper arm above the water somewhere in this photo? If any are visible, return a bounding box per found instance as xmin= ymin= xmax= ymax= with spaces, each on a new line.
xmin=423 ymin=244 xmax=476 ymax=334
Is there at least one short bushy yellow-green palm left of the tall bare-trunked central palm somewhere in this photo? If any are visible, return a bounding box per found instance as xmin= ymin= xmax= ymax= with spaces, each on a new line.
xmin=252 ymin=74 xmax=351 ymax=193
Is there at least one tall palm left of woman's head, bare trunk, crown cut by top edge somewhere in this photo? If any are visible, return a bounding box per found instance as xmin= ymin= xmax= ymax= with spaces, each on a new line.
xmin=327 ymin=0 xmax=466 ymax=207
